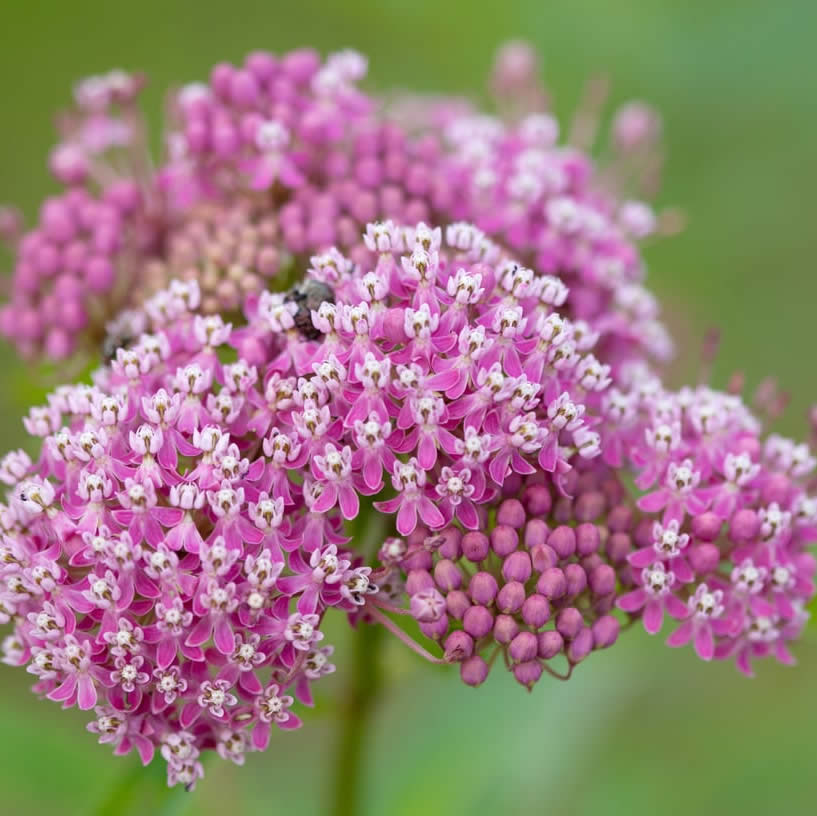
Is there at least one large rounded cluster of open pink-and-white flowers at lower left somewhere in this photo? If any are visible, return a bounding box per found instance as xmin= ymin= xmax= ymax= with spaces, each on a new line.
xmin=0 ymin=283 xmax=376 ymax=785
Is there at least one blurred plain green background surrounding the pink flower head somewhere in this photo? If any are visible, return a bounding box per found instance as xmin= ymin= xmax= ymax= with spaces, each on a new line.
xmin=0 ymin=0 xmax=817 ymax=816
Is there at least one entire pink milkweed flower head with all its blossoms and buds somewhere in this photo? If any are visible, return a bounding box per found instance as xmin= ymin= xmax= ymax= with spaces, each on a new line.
xmin=0 ymin=43 xmax=817 ymax=787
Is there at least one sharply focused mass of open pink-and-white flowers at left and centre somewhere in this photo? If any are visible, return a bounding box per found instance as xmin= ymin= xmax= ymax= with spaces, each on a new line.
xmin=0 ymin=217 xmax=632 ymax=779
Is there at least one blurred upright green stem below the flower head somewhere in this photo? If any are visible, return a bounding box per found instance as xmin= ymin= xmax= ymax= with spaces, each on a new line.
xmin=329 ymin=623 xmax=384 ymax=816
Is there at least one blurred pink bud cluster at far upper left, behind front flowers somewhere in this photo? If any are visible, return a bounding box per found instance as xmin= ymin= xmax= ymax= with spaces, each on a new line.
xmin=0 ymin=71 xmax=159 ymax=360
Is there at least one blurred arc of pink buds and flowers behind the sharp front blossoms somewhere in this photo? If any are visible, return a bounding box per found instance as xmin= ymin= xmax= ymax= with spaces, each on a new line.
xmin=0 ymin=44 xmax=671 ymax=376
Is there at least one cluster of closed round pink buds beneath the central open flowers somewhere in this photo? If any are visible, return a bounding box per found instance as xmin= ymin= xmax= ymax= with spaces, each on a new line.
xmin=386 ymin=460 xmax=634 ymax=689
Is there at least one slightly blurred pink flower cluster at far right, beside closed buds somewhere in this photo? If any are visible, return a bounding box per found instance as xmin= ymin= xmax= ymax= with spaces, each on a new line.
xmin=616 ymin=380 xmax=817 ymax=674
